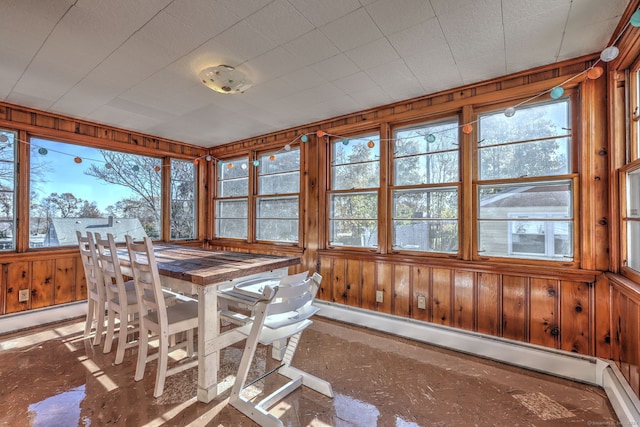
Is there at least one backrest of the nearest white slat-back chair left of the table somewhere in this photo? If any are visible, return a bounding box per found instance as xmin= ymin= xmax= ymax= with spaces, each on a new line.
xmin=125 ymin=235 xmax=167 ymax=330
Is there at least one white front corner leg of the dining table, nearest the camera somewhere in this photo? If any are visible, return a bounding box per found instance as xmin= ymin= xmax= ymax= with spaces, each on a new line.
xmin=198 ymin=286 xmax=220 ymax=403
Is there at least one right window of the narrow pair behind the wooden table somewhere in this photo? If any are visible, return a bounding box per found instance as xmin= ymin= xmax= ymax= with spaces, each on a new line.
xmin=256 ymin=148 xmax=300 ymax=242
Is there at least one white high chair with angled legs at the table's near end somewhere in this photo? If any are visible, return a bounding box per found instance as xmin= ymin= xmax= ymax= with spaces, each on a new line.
xmin=218 ymin=273 xmax=333 ymax=427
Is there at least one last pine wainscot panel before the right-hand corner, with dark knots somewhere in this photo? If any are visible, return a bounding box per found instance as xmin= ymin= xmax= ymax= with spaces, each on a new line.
xmin=560 ymin=281 xmax=590 ymax=354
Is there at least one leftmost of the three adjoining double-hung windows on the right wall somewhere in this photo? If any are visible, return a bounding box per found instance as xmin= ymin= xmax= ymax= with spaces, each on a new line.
xmin=328 ymin=134 xmax=380 ymax=248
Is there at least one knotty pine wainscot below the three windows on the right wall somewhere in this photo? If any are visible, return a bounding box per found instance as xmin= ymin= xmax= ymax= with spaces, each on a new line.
xmin=318 ymin=252 xmax=611 ymax=358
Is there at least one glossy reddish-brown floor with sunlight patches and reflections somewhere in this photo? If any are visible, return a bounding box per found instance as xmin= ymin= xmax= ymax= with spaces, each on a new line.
xmin=0 ymin=317 xmax=618 ymax=427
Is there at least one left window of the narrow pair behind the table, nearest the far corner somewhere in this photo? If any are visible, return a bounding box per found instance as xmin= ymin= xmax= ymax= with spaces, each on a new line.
xmin=215 ymin=158 xmax=249 ymax=239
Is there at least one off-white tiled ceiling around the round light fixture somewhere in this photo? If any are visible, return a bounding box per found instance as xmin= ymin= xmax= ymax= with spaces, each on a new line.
xmin=0 ymin=0 xmax=628 ymax=147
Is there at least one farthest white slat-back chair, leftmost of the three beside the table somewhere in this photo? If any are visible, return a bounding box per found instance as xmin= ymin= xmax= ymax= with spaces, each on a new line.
xmin=76 ymin=231 xmax=106 ymax=345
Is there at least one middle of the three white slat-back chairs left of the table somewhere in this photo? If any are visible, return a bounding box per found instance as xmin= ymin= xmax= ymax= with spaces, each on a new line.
xmin=95 ymin=233 xmax=139 ymax=365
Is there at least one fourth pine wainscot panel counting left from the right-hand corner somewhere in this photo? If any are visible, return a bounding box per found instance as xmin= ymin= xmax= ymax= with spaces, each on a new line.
xmin=476 ymin=273 xmax=502 ymax=336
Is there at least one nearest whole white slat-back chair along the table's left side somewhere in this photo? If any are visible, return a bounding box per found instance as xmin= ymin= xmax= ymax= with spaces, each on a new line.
xmin=125 ymin=236 xmax=198 ymax=397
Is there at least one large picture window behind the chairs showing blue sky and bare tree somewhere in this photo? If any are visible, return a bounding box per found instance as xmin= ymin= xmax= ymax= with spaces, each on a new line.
xmin=29 ymin=138 xmax=162 ymax=248
